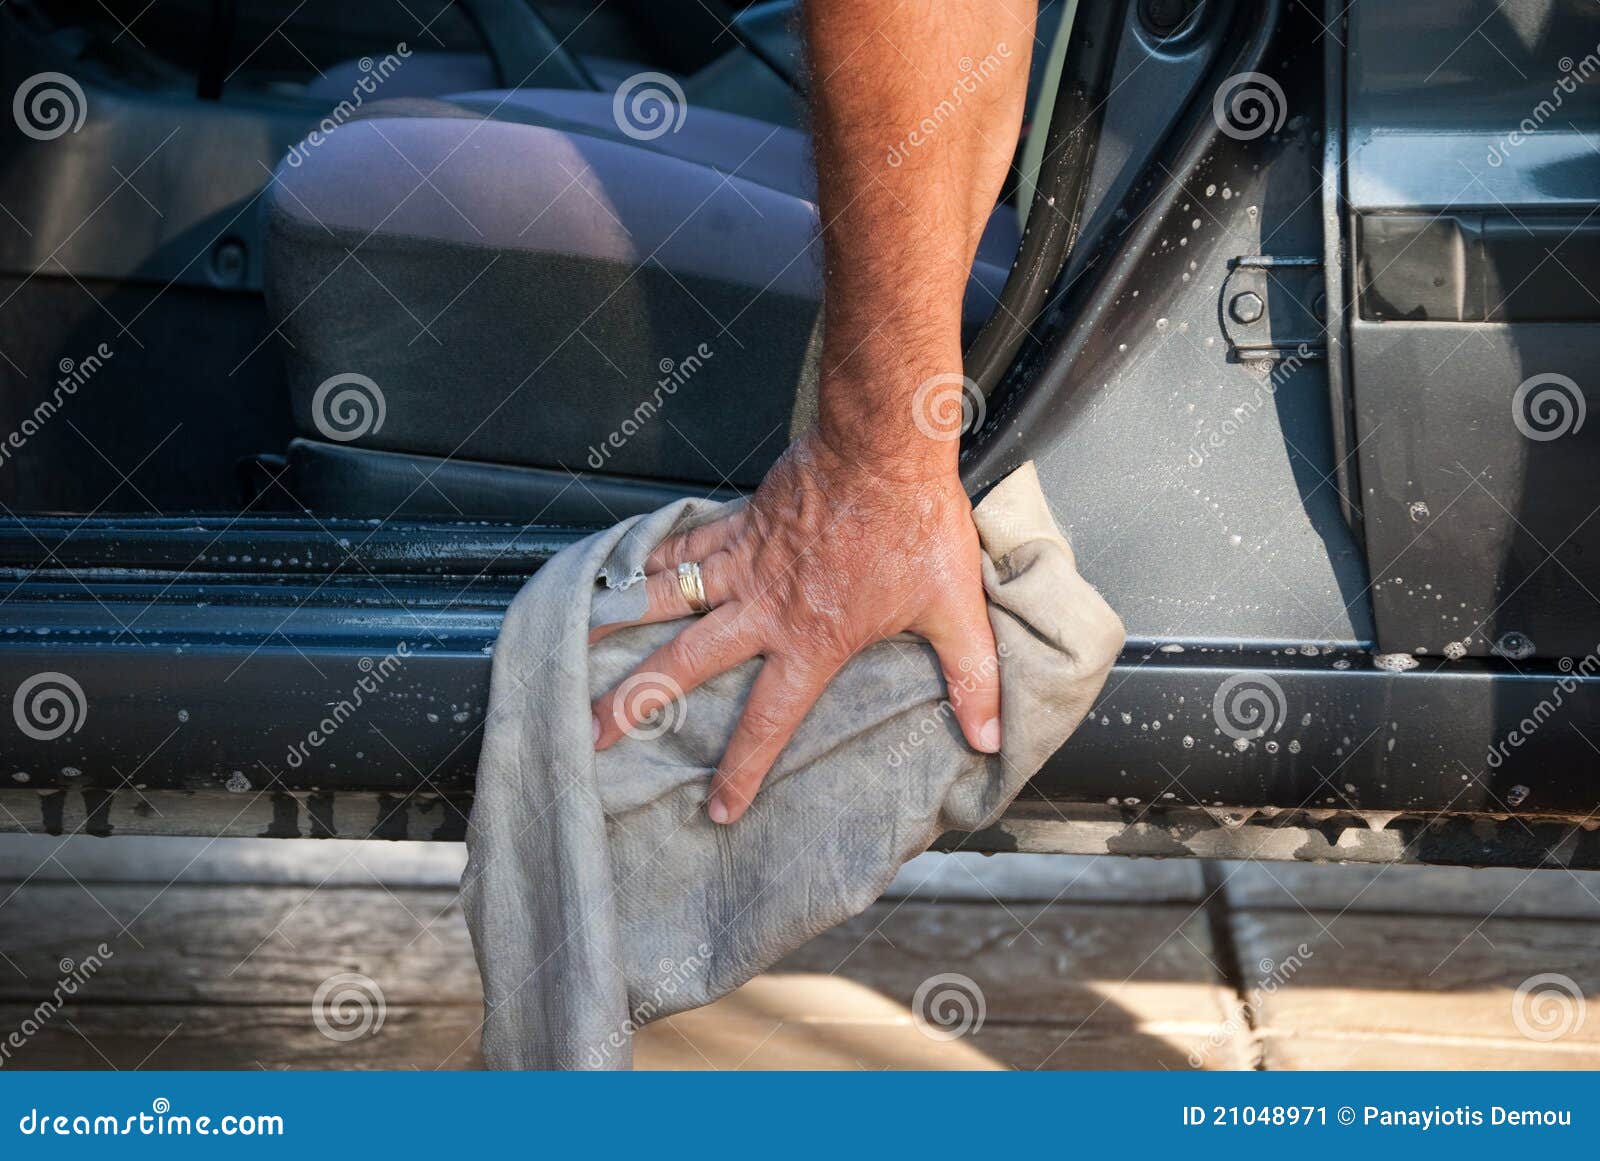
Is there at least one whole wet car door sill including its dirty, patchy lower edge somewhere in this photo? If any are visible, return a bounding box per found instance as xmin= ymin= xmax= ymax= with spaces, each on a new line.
xmin=0 ymin=517 xmax=1600 ymax=865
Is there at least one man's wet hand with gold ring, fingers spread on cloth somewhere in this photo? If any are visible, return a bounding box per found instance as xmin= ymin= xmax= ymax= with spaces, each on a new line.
xmin=594 ymin=430 xmax=1000 ymax=822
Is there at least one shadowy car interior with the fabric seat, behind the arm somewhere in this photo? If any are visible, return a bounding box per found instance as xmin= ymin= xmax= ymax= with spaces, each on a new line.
xmin=0 ymin=0 xmax=1059 ymax=525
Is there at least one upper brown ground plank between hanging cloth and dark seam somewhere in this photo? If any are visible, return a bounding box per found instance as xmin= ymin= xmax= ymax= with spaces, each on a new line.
xmin=776 ymin=902 xmax=1229 ymax=1027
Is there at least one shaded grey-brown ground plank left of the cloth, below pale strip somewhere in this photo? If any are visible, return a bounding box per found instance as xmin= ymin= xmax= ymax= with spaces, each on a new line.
xmin=0 ymin=883 xmax=480 ymax=1004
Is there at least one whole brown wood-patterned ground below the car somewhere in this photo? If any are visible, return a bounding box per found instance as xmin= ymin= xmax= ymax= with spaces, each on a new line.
xmin=0 ymin=836 xmax=1600 ymax=1068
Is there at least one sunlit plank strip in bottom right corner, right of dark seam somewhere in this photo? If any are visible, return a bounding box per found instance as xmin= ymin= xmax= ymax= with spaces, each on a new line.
xmin=1262 ymin=1033 xmax=1600 ymax=1071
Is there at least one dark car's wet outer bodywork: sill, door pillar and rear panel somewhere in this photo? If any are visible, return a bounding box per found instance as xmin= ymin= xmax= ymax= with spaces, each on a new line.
xmin=0 ymin=0 xmax=1600 ymax=865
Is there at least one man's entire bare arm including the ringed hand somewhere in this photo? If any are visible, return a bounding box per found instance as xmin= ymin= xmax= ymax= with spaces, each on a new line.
xmin=594 ymin=0 xmax=1035 ymax=824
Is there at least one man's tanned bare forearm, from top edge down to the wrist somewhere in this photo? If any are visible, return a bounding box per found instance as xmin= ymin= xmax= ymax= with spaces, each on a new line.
xmin=805 ymin=0 xmax=1035 ymax=470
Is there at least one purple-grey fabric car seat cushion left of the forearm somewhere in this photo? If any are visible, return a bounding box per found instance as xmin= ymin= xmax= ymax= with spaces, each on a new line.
xmin=266 ymin=90 xmax=1005 ymax=486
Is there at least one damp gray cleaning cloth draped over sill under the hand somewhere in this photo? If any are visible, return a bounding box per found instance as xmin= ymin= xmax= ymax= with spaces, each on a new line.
xmin=462 ymin=464 xmax=1123 ymax=1068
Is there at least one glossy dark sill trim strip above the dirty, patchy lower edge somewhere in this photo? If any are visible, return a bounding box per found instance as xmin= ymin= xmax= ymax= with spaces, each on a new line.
xmin=0 ymin=559 xmax=1600 ymax=820
